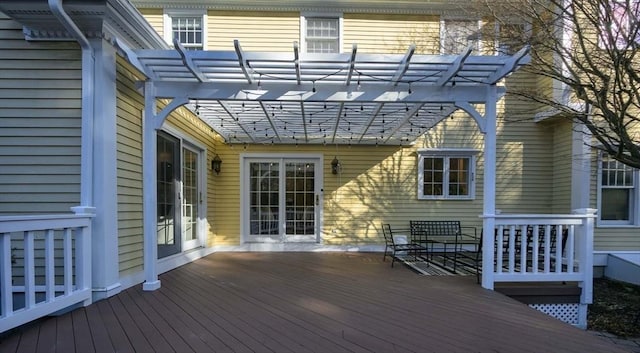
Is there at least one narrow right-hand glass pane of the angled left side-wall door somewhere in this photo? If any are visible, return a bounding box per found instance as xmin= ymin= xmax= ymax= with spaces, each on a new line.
xmin=182 ymin=148 xmax=199 ymax=241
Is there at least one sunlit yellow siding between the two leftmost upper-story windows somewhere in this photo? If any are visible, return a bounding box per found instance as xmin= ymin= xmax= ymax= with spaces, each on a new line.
xmin=207 ymin=11 xmax=300 ymax=52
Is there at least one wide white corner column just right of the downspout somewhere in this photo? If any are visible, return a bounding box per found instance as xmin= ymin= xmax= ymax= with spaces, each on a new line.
xmin=88 ymin=39 xmax=120 ymax=300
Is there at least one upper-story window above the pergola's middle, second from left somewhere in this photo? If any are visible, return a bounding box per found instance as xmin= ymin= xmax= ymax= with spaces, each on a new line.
xmin=302 ymin=15 xmax=342 ymax=53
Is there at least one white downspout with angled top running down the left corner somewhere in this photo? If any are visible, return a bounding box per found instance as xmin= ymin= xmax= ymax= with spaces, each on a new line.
xmin=48 ymin=0 xmax=95 ymax=214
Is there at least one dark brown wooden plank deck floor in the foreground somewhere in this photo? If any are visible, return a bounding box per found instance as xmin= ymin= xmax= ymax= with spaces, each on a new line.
xmin=0 ymin=253 xmax=623 ymax=353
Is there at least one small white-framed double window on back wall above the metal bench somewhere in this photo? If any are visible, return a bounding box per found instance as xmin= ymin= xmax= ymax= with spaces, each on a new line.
xmin=418 ymin=150 xmax=477 ymax=200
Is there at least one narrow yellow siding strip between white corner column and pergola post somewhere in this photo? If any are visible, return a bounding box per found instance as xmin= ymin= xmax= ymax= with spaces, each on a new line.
xmin=116 ymin=58 xmax=144 ymax=276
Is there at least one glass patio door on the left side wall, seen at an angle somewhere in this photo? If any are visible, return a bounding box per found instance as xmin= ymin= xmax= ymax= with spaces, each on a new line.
xmin=157 ymin=132 xmax=202 ymax=258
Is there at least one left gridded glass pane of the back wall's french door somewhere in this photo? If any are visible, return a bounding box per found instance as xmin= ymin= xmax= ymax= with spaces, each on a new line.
xmin=249 ymin=162 xmax=280 ymax=235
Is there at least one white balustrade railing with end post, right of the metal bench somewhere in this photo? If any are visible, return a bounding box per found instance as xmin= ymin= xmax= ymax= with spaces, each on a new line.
xmin=482 ymin=209 xmax=595 ymax=325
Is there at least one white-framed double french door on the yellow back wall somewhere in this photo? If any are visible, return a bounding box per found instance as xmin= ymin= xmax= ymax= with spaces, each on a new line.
xmin=243 ymin=158 xmax=321 ymax=243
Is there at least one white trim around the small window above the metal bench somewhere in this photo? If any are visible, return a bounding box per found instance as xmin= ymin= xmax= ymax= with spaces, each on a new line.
xmin=417 ymin=148 xmax=480 ymax=201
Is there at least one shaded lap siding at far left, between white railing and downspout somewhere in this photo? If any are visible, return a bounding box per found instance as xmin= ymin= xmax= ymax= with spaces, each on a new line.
xmin=0 ymin=13 xmax=82 ymax=214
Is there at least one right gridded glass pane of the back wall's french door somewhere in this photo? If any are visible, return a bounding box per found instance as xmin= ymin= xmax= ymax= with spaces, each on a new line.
xmin=285 ymin=162 xmax=315 ymax=236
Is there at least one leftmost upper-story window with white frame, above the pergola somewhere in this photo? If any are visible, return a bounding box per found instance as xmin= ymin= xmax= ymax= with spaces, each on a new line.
xmin=165 ymin=12 xmax=206 ymax=50
